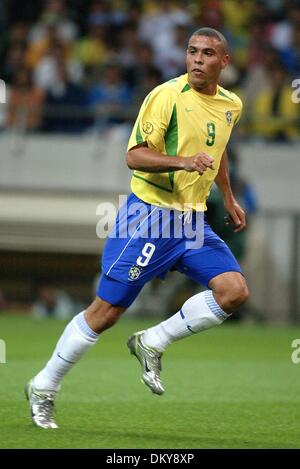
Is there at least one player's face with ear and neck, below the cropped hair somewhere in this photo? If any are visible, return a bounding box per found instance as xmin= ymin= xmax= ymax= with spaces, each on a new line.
xmin=186 ymin=36 xmax=229 ymax=94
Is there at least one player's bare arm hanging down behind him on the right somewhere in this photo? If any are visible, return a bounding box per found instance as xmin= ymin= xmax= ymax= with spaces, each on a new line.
xmin=215 ymin=150 xmax=246 ymax=232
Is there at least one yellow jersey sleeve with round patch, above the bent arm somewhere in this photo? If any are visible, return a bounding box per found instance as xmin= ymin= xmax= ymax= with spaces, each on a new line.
xmin=127 ymin=87 xmax=175 ymax=152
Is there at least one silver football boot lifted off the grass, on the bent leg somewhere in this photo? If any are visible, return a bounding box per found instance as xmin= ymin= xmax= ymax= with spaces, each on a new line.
xmin=127 ymin=331 xmax=165 ymax=395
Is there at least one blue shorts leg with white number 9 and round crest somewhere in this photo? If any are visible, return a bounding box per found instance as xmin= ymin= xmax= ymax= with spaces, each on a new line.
xmin=97 ymin=195 xmax=185 ymax=307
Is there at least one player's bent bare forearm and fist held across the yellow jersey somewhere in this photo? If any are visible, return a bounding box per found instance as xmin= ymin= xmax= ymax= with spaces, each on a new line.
xmin=126 ymin=144 xmax=214 ymax=175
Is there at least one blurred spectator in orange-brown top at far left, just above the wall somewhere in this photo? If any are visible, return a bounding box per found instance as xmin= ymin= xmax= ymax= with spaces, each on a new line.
xmin=6 ymin=67 xmax=45 ymax=130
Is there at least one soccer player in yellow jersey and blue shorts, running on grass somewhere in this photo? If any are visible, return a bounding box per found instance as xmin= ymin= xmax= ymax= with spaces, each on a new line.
xmin=26 ymin=28 xmax=248 ymax=428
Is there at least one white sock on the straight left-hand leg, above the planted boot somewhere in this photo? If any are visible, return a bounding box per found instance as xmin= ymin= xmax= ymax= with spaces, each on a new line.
xmin=33 ymin=311 xmax=99 ymax=391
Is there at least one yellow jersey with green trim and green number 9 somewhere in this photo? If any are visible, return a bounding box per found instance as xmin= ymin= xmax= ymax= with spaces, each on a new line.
xmin=127 ymin=74 xmax=242 ymax=211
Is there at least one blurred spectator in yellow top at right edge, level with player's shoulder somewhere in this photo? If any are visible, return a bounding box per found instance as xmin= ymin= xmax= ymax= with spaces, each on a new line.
xmin=252 ymin=67 xmax=299 ymax=142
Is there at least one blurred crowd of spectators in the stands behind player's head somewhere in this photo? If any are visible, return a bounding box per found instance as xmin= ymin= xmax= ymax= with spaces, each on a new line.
xmin=0 ymin=0 xmax=300 ymax=142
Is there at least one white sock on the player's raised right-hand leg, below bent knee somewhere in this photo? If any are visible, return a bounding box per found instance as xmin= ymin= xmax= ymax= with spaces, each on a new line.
xmin=143 ymin=290 xmax=230 ymax=352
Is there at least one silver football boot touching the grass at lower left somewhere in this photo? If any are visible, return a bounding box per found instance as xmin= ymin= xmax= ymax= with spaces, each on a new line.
xmin=25 ymin=380 xmax=58 ymax=429
